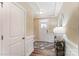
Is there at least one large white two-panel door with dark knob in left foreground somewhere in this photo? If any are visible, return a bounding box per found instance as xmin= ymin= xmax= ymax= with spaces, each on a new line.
xmin=2 ymin=3 xmax=25 ymax=56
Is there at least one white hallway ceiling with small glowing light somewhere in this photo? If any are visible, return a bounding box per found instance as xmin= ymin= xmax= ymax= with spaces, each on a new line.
xmin=28 ymin=2 xmax=63 ymax=17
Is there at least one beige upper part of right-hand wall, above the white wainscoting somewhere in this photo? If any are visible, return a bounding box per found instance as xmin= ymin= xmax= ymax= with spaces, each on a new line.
xmin=61 ymin=3 xmax=79 ymax=44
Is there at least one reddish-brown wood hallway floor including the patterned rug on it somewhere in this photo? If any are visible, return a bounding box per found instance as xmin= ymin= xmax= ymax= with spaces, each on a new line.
xmin=31 ymin=41 xmax=56 ymax=56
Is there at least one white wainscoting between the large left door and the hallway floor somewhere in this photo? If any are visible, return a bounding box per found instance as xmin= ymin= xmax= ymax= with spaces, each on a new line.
xmin=25 ymin=35 xmax=34 ymax=56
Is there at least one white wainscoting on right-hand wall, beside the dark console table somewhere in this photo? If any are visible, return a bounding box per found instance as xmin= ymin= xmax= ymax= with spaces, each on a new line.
xmin=64 ymin=35 xmax=78 ymax=56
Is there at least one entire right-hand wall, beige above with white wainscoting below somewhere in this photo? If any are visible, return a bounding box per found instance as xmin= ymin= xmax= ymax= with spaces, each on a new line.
xmin=61 ymin=3 xmax=79 ymax=56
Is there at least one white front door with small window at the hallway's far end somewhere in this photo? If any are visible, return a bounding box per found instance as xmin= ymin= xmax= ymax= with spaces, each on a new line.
xmin=39 ymin=19 xmax=49 ymax=42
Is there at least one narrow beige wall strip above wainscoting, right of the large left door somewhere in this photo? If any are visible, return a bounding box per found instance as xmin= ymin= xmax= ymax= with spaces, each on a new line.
xmin=26 ymin=9 xmax=33 ymax=35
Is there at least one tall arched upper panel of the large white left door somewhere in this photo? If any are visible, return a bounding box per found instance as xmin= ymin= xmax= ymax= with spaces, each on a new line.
xmin=10 ymin=5 xmax=24 ymax=36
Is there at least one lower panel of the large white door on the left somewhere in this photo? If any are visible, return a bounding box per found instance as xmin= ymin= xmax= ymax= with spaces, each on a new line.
xmin=10 ymin=40 xmax=24 ymax=56
